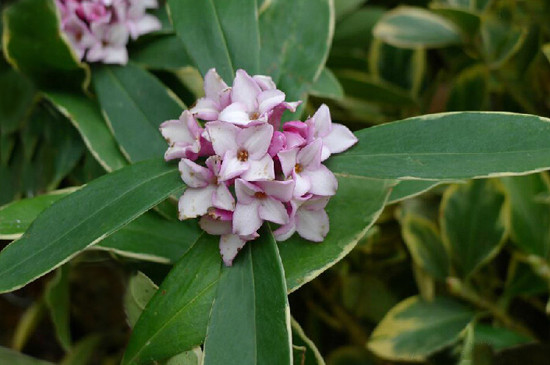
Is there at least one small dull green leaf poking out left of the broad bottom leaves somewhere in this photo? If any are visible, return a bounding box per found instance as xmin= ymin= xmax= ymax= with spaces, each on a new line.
xmin=124 ymin=271 xmax=159 ymax=328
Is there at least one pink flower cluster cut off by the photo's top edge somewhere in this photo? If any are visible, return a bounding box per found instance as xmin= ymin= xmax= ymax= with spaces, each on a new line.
xmin=56 ymin=0 xmax=161 ymax=64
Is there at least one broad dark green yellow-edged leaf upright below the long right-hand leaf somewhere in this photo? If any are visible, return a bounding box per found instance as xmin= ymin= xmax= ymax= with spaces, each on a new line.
xmin=440 ymin=180 xmax=508 ymax=277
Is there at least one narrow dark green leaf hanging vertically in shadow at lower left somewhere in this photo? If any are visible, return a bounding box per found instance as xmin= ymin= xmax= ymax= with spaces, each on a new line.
xmin=45 ymin=265 xmax=71 ymax=350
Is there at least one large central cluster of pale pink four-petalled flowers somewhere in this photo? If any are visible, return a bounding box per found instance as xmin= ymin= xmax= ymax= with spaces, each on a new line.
xmin=160 ymin=69 xmax=357 ymax=266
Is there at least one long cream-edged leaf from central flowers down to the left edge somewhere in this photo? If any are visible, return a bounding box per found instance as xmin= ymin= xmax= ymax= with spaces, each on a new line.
xmin=0 ymin=160 xmax=183 ymax=292
